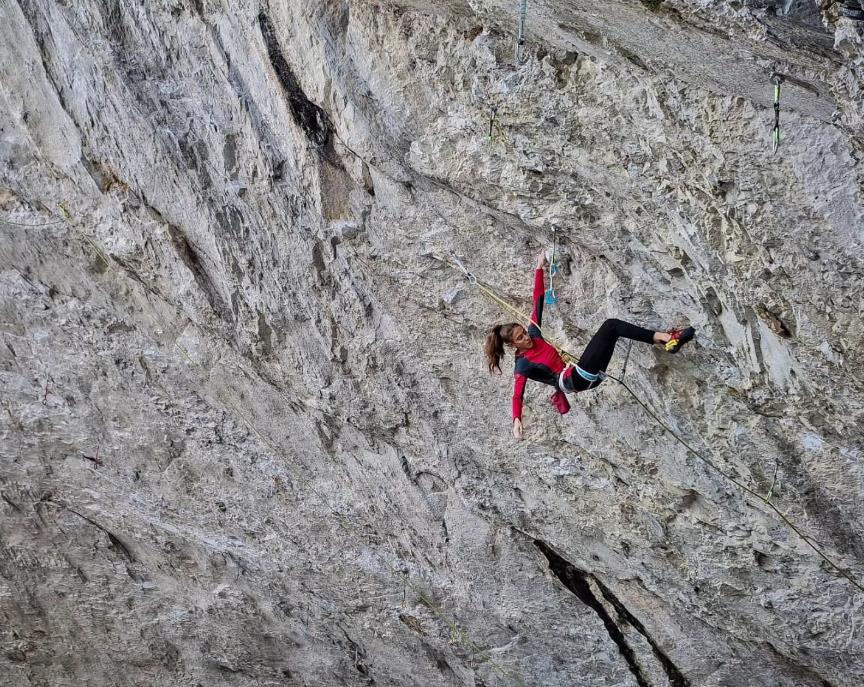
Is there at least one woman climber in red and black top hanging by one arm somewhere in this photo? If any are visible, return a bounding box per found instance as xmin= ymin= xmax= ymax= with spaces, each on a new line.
xmin=484 ymin=252 xmax=696 ymax=439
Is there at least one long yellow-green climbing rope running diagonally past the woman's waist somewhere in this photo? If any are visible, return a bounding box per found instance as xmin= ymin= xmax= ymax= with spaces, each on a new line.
xmin=453 ymin=255 xmax=864 ymax=592
